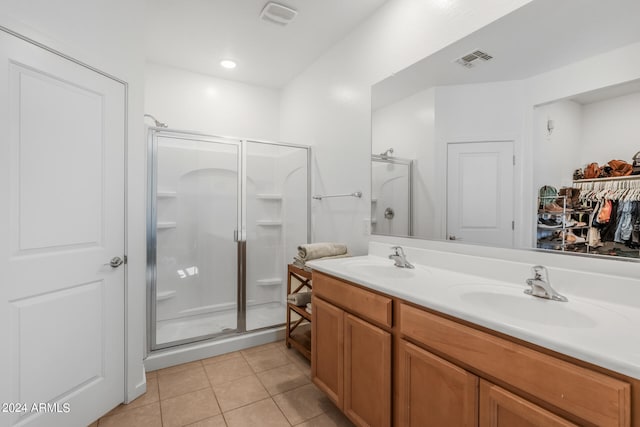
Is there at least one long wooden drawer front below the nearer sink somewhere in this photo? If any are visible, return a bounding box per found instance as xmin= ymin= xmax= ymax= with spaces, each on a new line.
xmin=399 ymin=304 xmax=631 ymax=426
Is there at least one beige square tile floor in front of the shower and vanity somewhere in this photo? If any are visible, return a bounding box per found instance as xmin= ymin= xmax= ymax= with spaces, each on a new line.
xmin=90 ymin=341 xmax=353 ymax=427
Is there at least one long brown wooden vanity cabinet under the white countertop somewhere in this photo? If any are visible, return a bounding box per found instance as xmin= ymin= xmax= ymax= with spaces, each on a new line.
xmin=312 ymin=272 xmax=640 ymax=427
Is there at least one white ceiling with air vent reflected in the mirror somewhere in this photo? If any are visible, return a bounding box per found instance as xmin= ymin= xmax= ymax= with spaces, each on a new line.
xmin=372 ymin=0 xmax=640 ymax=110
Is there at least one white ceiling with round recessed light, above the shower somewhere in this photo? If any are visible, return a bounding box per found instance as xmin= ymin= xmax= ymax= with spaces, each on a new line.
xmin=145 ymin=0 xmax=387 ymax=88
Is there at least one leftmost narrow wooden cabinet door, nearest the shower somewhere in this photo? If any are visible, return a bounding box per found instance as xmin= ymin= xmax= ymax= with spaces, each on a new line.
xmin=311 ymin=296 xmax=344 ymax=409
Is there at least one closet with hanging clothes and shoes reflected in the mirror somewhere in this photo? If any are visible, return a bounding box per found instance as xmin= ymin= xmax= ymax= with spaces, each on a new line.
xmin=533 ymin=80 xmax=640 ymax=259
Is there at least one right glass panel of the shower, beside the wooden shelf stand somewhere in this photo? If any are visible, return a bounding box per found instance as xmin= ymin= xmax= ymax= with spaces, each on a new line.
xmin=244 ymin=141 xmax=309 ymax=331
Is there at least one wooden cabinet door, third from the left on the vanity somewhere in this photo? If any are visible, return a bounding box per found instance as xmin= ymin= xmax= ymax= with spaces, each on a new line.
xmin=397 ymin=340 xmax=478 ymax=427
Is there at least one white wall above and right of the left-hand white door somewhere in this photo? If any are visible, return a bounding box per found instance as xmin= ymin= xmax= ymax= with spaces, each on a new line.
xmin=0 ymin=0 xmax=146 ymax=399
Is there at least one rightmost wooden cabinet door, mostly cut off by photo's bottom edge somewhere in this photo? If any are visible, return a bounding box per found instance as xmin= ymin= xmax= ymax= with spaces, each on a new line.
xmin=480 ymin=381 xmax=576 ymax=427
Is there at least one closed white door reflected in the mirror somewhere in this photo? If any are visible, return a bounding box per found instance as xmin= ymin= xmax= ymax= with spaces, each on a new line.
xmin=447 ymin=141 xmax=514 ymax=247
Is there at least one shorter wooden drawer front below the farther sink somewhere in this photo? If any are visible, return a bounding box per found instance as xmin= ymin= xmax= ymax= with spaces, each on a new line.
xmin=313 ymin=271 xmax=393 ymax=328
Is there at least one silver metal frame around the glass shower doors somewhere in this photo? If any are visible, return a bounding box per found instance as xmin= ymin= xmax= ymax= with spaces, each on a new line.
xmin=145 ymin=126 xmax=311 ymax=355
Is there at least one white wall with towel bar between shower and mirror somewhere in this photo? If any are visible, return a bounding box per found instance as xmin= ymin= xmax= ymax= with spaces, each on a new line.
xmin=281 ymin=0 xmax=529 ymax=254
